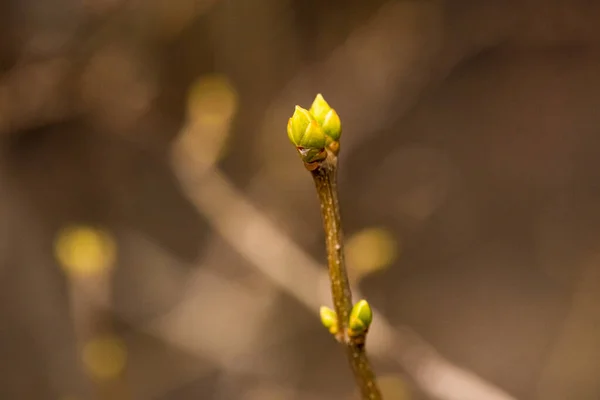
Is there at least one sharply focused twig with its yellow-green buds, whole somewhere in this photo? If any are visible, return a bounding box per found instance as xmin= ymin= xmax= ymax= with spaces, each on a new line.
xmin=288 ymin=94 xmax=381 ymax=400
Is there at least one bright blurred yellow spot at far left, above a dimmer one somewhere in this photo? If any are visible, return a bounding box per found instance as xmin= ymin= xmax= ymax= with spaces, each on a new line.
xmin=54 ymin=226 xmax=117 ymax=276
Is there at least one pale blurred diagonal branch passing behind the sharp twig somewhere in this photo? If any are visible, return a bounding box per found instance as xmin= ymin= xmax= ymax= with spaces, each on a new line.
xmin=169 ymin=145 xmax=514 ymax=400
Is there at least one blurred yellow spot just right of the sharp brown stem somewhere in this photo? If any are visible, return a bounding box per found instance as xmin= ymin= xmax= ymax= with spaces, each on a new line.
xmin=346 ymin=227 xmax=399 ymax=281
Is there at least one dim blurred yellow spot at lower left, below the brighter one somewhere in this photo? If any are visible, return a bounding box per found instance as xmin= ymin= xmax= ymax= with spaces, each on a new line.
xmin=82 ymin=336 xmax=127 ymax=380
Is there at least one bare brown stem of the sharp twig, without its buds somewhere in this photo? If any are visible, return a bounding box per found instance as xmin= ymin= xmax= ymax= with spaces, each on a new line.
xmin=311 ymin=152 xmax=381 ymax=400
